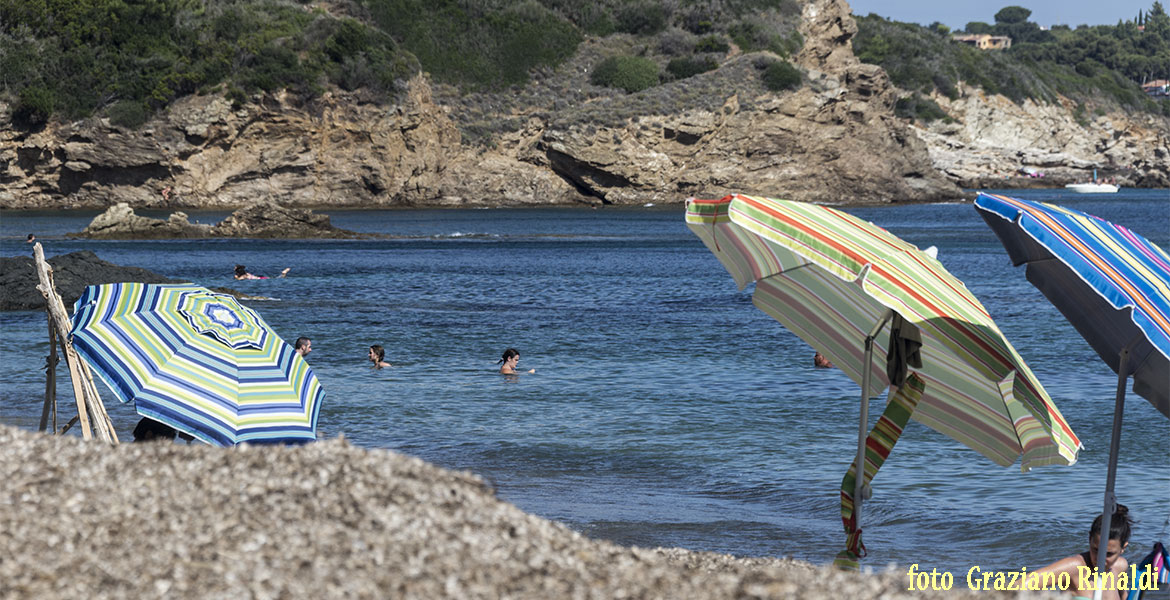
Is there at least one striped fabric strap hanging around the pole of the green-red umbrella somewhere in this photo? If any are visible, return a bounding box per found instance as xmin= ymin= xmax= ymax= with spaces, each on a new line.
xmin=833 ymin=373 xmax=925 ymax=571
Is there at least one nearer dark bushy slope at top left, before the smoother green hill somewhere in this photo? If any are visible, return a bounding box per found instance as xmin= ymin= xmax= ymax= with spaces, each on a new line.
xmin=0 ymin=0 xmax=418 ymax=125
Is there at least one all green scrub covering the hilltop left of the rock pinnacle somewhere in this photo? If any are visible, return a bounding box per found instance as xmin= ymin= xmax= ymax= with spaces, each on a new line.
xmin=0 ymin=0 xmax=803 ymax=126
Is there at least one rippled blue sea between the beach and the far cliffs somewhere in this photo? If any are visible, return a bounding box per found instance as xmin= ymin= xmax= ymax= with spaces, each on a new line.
xmin=0 ymin=189 xmax=1170 ymax=578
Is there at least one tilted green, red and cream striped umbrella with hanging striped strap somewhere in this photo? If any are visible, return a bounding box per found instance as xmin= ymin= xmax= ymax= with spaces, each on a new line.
xmin=687 ymin=194 xmax=1081 ymax=566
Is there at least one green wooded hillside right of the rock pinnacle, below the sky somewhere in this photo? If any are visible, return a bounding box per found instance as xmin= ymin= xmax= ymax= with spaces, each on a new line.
xmin=853 ymin=2 xmax=1170 ymax=120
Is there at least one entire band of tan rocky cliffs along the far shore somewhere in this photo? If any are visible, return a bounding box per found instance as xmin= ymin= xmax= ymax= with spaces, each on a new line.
xmin=0 ymin=0 xmax=1170 ymax=208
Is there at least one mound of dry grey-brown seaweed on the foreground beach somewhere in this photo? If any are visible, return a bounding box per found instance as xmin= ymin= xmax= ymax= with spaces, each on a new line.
xmin=0 ymin=426 xmax=1057 ymax=599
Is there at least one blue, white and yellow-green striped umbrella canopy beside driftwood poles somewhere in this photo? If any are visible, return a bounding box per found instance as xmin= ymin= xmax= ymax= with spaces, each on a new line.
xmin=71 ymin=283 xmax=325 ymax=446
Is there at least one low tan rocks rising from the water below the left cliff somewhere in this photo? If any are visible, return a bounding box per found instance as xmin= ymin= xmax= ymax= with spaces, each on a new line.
xmin=70 ymin=199 xmax=363 ymax=240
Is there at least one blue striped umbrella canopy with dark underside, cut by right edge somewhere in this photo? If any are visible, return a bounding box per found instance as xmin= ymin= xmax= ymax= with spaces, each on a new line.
xmin=975 ymin=194 xmax=1170 ymax=418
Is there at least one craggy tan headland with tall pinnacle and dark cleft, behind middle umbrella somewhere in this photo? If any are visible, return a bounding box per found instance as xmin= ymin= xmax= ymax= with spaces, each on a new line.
xmin=442 ymin=0 xmax=962 ymax=205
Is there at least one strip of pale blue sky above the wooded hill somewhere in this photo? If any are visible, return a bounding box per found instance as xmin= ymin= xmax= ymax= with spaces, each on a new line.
xmin=846 ymin=0 xmax=1151 ymax=29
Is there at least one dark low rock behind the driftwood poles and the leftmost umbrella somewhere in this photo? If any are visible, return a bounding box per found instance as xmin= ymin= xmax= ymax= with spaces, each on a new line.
xmin=0 ymin=250 xmax=183 ymax=310
